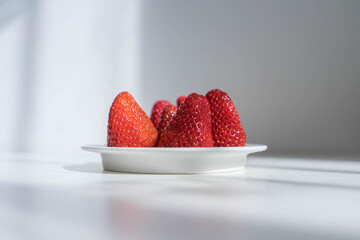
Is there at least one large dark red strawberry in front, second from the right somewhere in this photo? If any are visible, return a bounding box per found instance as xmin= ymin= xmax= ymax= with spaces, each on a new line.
xmin=158 ymin=93 xmax=214 ymax=147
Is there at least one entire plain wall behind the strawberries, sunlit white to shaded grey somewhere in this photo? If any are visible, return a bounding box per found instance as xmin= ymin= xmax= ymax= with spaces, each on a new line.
xmin=0 ymin=0 xmax=360 ymax=152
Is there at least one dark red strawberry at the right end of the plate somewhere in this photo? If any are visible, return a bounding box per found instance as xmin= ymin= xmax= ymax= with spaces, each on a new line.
xmin=206 ymin=89 xmax=246 ymax=147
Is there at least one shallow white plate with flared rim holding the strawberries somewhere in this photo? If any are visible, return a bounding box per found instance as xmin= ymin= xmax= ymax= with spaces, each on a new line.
xmin=81 ymin=144 xmax=267 ymax=174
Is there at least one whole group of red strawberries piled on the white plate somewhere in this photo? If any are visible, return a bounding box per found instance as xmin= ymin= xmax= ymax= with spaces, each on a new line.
xmin=107 ymin=89 xmax=246 ymax=147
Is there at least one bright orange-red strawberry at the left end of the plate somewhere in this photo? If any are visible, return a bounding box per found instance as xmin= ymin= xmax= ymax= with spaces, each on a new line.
xmin=108 ymin=92 xmax=158 ymax=147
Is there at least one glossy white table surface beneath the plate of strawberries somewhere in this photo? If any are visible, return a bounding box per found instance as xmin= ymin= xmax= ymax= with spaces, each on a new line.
xmin=0 ymin=153 xmax=360 ymax=240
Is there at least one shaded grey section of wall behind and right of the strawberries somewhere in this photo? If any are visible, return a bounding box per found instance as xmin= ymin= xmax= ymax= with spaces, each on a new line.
xmin=141 ymin=1 xmax=360 ymax=152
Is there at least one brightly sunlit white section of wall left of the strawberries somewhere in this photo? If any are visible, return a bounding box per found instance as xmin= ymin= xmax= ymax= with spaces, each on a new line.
xmin=0 ymin=0 xmax=141 ymax=152
